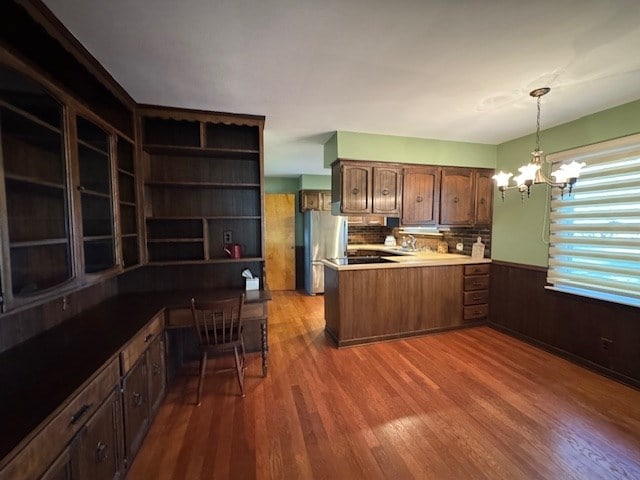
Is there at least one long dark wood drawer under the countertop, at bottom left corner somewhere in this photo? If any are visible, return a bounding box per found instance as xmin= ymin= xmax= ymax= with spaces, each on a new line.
xmin=0 ymin=358 xmax=120 ymax=479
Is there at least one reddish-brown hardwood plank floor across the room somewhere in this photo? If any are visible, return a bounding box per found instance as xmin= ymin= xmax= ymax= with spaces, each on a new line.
xmin=128 ymin=292 xmax=640 ymax=480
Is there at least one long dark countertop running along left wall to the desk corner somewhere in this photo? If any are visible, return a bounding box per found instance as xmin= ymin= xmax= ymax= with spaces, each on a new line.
xmin=0 ymin=289 xmax=271 ymax=459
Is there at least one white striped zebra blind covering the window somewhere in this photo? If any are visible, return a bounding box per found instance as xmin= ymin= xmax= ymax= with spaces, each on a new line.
xmin=547 ymin=135 xmax=640 ymax=306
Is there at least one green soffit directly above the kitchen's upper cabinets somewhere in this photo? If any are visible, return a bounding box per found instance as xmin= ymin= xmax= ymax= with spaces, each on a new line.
xmin=324 ymin=131 xmax=497 ymax=168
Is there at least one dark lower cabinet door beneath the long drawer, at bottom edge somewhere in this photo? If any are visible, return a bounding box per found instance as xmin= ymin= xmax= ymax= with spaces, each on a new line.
xmin=73 ymin=388 xmax=124 ymax=480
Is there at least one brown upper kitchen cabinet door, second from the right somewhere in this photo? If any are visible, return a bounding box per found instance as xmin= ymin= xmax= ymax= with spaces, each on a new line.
xmin=440 ymin=167 xmax=475 ymax=227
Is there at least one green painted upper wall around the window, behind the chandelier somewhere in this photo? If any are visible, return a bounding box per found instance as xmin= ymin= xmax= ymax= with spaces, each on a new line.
xmin=491 ymin=100 xmax=640 ymax=267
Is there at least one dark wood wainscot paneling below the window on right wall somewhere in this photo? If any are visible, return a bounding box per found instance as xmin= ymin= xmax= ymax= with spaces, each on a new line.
xmin=489 ymin=262 xmax=640 ymax=388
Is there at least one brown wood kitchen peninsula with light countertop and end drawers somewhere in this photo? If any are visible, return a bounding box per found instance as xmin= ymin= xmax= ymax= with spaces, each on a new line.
xmin=324 ymin=245 xmax=491 ymax=347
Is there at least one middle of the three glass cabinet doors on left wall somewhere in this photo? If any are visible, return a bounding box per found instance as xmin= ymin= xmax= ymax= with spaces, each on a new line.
xmin=76 ymin=117 xmax=115 ymax=273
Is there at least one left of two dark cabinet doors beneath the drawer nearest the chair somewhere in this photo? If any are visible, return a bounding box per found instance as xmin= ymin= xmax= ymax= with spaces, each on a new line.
xmin=123 ymin=352 xmax=149 ymax=465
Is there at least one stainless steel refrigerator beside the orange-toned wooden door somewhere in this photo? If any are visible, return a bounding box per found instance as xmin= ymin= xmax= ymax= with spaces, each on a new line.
xmin=304 ymin=210 xmax=347 ymax=295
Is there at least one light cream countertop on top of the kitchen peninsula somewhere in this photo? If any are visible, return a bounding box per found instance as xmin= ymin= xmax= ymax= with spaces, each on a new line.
xmin=322 ymin=248 xmax=491 ymax=271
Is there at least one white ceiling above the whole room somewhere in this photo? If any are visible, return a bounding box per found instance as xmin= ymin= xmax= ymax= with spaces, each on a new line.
xmin=44 ymin=0 xmax=640 ymax=175
